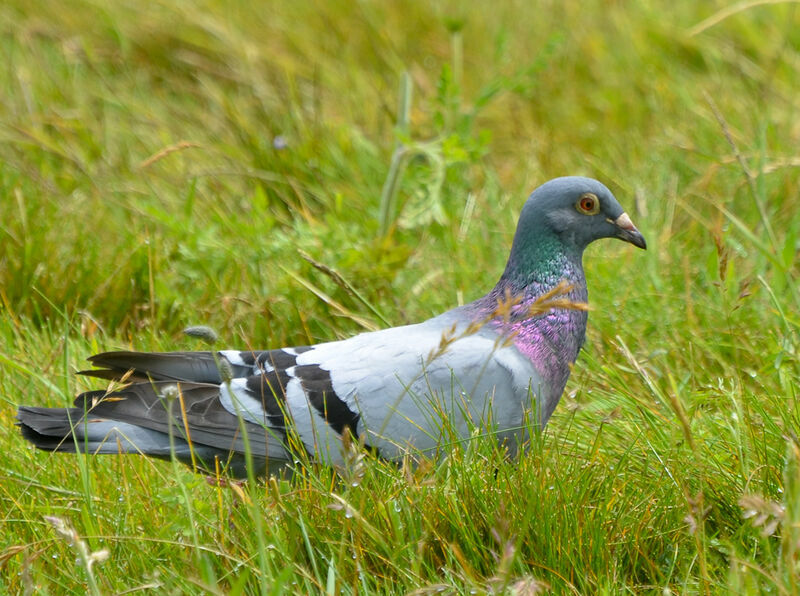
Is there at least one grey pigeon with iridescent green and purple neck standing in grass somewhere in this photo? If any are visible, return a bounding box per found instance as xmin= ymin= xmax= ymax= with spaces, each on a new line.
xmin=17 ymin=176 xmax=646 ymax=477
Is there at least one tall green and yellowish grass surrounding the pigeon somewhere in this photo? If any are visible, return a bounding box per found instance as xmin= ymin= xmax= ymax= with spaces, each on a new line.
xmin=0 ymin=0 xmax=800 ymax=594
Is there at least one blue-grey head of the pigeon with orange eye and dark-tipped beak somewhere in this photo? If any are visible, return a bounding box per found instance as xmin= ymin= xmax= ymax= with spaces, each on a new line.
xmin=519 ymin=176 xmax=647 ymax=252
